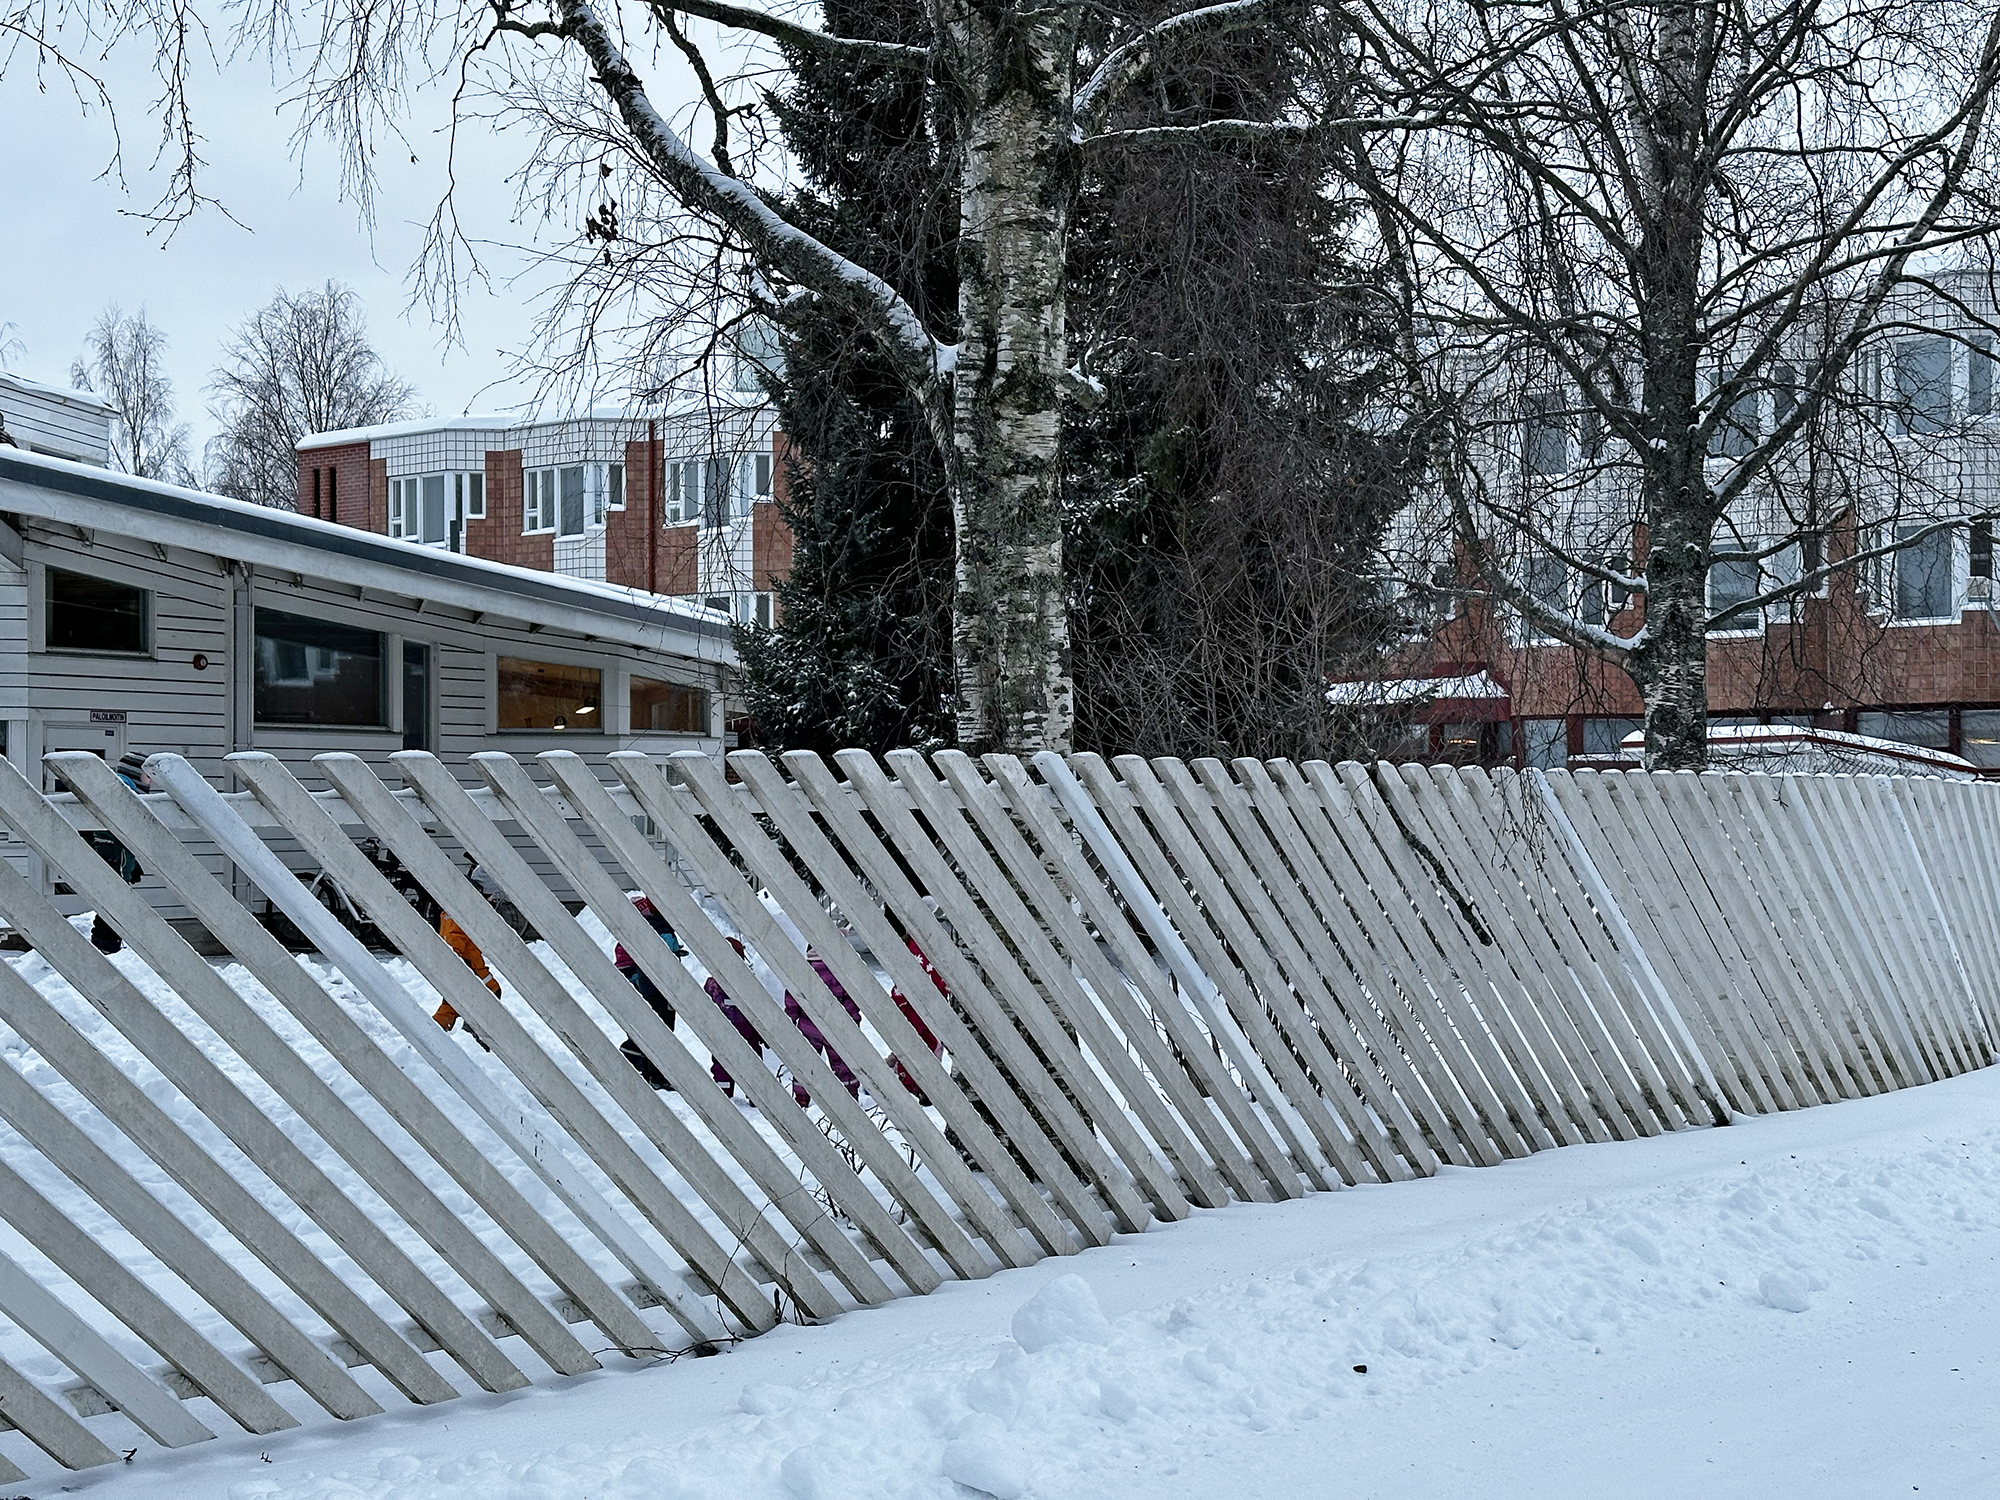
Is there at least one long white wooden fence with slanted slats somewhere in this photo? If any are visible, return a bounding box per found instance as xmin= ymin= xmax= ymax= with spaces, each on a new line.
xmin=0 ymin=752 xmax=2000 ymax=1480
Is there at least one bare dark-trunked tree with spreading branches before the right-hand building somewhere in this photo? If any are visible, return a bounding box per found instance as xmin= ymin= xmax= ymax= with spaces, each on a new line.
xmin=1324 ymin=0 xmax=2000 ymax=768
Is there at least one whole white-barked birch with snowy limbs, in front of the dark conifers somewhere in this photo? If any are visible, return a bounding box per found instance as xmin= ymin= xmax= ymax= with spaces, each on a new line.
xmin=250 ymin=0 xmax=1306 ymax=750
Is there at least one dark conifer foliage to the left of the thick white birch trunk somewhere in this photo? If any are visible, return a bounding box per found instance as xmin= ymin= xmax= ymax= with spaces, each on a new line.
xmin=742 ymin=0 xmax=958 ymax=752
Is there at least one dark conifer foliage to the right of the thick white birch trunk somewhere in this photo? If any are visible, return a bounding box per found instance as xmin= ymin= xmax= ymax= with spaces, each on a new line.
xmin=1064 ymin=26 xmax=1412 ymax=756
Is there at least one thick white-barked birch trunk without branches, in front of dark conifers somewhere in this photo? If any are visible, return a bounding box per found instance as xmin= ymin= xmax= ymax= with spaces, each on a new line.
xmin=952 ymin=6 xmax=1076 ymax=754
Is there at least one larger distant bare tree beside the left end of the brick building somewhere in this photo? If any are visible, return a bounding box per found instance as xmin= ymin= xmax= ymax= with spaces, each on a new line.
xmin=208 ymin=280 xmax=416 ymax=510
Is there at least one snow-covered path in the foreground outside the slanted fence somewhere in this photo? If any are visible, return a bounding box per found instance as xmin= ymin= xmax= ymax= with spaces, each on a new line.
xmin=35 ymin=1068 xmax=2000 ymax=1500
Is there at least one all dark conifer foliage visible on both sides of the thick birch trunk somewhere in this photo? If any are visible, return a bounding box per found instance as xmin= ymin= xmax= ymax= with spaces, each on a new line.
xmin=744 ymin=0 xmax=1406 ymax=756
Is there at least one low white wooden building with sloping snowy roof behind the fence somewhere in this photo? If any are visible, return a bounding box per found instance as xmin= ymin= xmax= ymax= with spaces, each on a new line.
xmin=0 ymin=438 xmax=736 ymax=928
